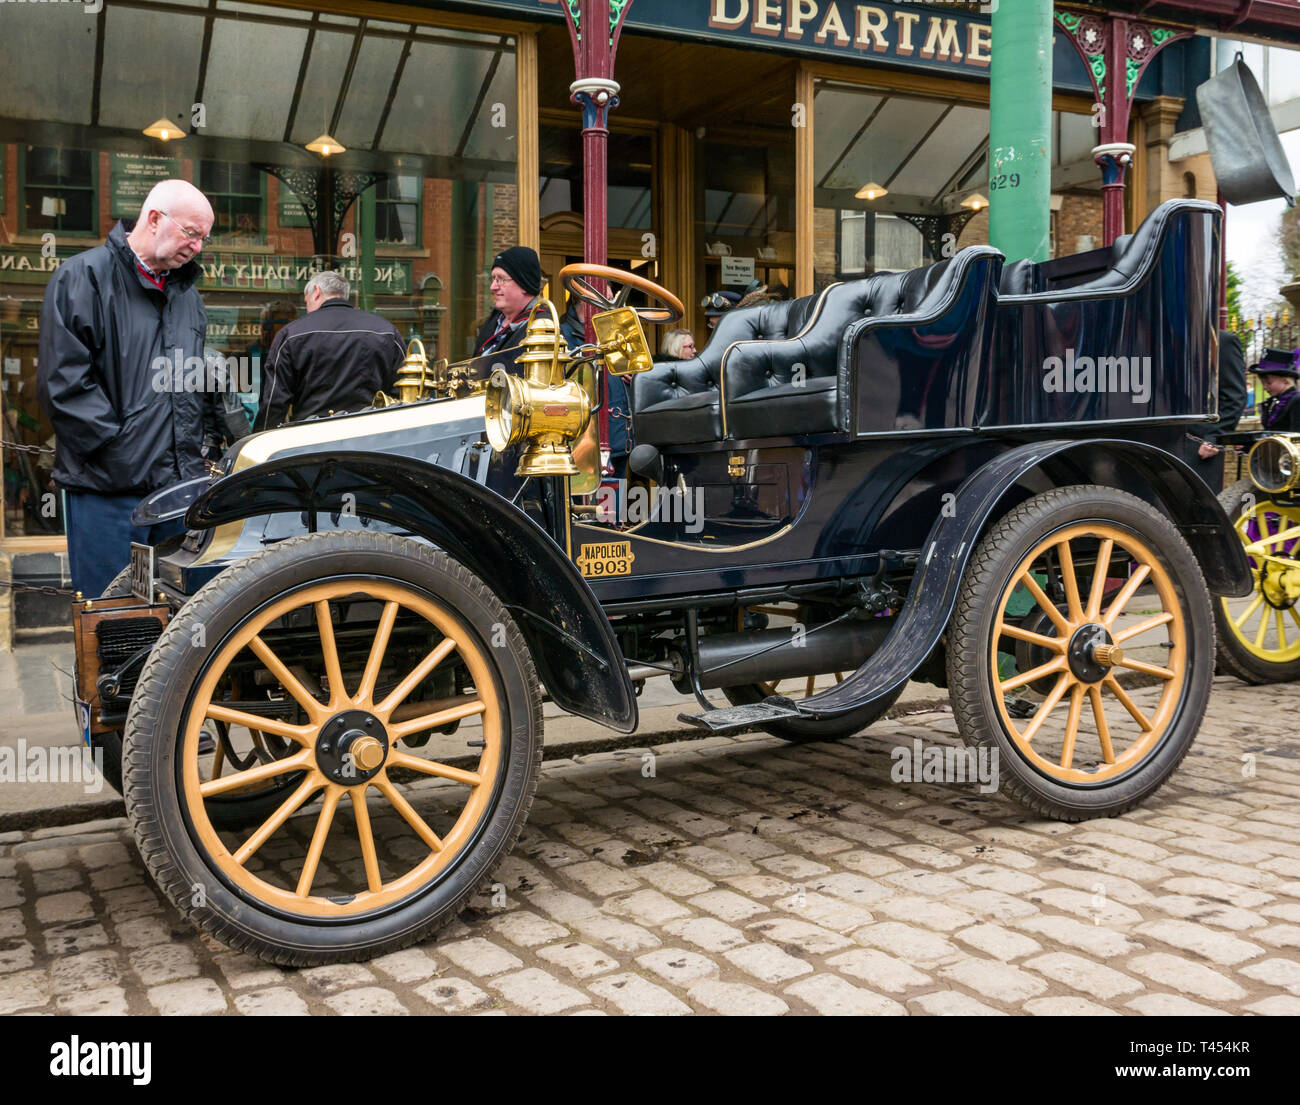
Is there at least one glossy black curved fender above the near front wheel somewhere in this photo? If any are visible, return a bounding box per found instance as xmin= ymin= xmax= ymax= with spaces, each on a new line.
xmin=186 ymin=452 xmax=637 ymax=733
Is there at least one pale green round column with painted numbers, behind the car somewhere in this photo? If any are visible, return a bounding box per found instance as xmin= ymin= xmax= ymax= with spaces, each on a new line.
xmin=988 ymin=0 xmax=1052 ymax=261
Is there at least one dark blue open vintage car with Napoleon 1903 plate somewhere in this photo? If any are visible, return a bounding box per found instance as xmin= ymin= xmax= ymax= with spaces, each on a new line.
xmin=78 ymin=202 xmax=1252 ymax=963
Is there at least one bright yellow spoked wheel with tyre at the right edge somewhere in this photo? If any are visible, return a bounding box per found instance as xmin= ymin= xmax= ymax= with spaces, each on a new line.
xmin=1214 ymin=480 xmax=1300 ymax=684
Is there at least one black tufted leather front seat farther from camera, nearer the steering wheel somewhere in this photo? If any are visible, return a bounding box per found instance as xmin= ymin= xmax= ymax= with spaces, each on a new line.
xmin=632 ymin=293 xmax=826 ymax=446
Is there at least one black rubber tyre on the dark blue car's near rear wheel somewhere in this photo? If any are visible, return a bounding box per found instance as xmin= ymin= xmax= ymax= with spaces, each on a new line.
xmin=948 ymin=486 xmax=1214 ymax=822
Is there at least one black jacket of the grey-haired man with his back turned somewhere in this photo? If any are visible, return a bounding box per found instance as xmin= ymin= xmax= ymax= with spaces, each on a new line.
xmin=254 ymin=299 xmax=406 ymax=430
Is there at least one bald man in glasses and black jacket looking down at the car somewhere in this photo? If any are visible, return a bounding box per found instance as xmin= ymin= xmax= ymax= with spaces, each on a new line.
xmin=36 ymin=181 xmax=213 ymax=597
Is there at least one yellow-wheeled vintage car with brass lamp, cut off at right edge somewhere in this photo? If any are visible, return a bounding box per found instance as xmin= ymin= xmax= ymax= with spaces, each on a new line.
xmin=1214 ymin=430 xmax=1300 ymax=684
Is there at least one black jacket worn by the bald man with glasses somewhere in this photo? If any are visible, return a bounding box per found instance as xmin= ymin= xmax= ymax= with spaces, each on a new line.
xmin=36 ymin=220 xmax=208 ymax=494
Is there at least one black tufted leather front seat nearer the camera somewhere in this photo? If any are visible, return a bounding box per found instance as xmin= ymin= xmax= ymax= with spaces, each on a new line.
xmin=723 ymin=246 xmax=1001 ymax=439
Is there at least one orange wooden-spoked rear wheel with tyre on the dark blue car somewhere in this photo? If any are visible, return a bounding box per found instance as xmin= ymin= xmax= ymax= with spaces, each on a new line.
xmin=948 ymin=488 xmax=1213 ymax=820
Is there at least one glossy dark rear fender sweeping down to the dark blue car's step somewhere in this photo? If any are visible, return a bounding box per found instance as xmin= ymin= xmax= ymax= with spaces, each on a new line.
xmin=767 ymin=439 xmax=1253 ymax=718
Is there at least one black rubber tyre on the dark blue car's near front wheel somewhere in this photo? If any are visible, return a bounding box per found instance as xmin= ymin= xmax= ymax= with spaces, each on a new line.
xmin=125 ymin=532 xmax=542 ymax=966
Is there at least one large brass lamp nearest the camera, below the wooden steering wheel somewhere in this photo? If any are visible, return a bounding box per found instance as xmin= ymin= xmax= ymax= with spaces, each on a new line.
xmin=484 ymin=299 xmax=592 ymax=476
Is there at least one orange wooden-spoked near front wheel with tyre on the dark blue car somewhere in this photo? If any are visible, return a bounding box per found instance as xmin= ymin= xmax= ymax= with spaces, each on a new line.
xmin=124 ymin=532 xmax=541 ymax=965
